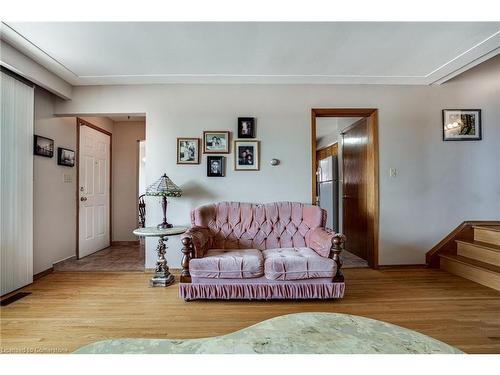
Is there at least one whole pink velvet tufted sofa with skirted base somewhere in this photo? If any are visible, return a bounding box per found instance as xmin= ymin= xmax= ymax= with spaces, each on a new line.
xmin=180 ymin=202 xmax=345 ymax=300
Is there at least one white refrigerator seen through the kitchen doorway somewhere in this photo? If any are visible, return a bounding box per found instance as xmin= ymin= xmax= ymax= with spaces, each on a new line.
xmin=316 ymin=156 xmax=339 ymax=232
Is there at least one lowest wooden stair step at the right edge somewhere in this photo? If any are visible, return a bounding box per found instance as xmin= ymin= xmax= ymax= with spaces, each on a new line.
xmin=440 ymin=254 xmax=500 ymax=291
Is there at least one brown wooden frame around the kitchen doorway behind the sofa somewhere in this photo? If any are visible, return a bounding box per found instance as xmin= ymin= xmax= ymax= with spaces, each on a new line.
xmin=311 ymin=108 xmax=379 ymax=269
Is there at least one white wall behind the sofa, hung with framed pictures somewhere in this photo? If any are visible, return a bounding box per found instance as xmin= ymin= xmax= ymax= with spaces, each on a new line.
xmin=56 ymin=56 xmax=500 ymax=267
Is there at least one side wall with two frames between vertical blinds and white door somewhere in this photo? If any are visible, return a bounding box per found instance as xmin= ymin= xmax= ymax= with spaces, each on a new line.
xmin=33 ymin=88 xmax=76 ymax=274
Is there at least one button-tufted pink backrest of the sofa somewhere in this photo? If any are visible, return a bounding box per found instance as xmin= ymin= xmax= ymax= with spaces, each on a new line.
xmin=191 ymin=202 xmax=326 ymax=250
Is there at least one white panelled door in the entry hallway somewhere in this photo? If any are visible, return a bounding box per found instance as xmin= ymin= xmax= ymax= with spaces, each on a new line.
xmin=78 ymin=126 xmax=111 ymax=258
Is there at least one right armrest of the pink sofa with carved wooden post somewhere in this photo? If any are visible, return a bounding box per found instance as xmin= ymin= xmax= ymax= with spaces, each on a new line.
xmin=306 ymin=228 xmax=346 ymax=282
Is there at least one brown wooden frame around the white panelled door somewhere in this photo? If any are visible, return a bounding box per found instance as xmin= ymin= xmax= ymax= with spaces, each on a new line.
xmin=76 ymin=117 xmax=113 ymax=259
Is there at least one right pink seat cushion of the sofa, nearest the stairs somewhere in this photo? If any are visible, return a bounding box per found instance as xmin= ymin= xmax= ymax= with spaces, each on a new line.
xmin=262 ymin=247 xmax=336 ymax=280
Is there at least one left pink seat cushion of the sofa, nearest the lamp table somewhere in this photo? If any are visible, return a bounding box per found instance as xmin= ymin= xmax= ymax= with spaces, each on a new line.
xmin=189 ymin=249 xmax=264 ymax=279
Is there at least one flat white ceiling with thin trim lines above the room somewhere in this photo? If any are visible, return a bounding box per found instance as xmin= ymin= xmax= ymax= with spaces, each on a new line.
xmin=2 ymin=22 xmax=500 ymax=85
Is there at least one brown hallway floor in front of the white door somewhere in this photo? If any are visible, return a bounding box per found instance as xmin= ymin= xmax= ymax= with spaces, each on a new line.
xmin=54 ymin=244 xmax=144 ymax=272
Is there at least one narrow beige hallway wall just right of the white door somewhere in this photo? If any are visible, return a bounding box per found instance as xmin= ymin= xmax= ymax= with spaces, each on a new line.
xmin=111 ymin=121 xmax=146 ymax=241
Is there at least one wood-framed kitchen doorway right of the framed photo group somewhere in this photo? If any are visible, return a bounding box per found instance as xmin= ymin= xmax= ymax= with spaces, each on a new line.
xmin=311 ymin=108 xmax=379 ymax=268
